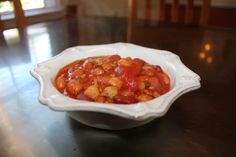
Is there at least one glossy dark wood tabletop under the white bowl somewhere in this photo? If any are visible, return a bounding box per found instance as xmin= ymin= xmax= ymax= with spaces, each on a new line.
xmin=0 ymin=17 xmax=236 ymax=157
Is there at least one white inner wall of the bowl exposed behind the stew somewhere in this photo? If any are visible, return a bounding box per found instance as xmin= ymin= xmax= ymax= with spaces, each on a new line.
xmin=45 ymin=48 xmax=176 ymax=93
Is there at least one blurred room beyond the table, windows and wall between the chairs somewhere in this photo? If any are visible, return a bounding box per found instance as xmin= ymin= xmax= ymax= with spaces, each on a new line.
xmin=0 ymin=0 xmax=236 ymax=29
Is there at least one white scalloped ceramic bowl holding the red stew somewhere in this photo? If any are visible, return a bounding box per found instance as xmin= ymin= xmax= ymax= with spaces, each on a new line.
xmin=30 ymin=43 xmax=201 ymax=129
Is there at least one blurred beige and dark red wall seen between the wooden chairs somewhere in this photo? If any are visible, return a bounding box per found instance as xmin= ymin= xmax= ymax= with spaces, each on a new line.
xmin=73 ymin=0 xmax=236 ymax=28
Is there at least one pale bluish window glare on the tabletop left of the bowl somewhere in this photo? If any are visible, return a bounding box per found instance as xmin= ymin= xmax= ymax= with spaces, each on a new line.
xmin=0 ymin=25 xmax=64 ymax=157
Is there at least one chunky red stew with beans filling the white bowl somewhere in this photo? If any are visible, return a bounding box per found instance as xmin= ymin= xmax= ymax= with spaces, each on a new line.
xmin=55 ymin=55 xmax=170 ymax=104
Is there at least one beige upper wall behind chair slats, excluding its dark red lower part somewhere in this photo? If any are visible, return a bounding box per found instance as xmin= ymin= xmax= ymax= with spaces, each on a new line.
xmin=75 ymin=0 xmax=236 ymax=17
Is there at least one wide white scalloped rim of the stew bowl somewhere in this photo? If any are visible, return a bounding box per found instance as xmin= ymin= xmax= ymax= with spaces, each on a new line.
xmin=30 ymin=43 xmax=201 ymax=121
